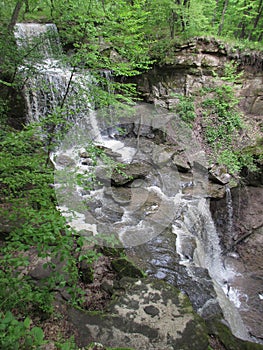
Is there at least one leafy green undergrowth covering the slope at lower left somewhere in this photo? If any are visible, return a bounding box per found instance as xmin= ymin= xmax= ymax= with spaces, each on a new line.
xmin=0 ymin=125 xmax=107 ymax=350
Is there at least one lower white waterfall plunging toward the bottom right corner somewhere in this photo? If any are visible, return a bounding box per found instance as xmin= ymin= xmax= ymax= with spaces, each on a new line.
xmin=174 ymin=198 xmax=249 ymax=340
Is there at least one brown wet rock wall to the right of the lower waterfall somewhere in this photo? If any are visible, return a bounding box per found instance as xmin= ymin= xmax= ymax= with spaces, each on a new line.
xmin=211 ymin=186 xmax=263 ymax=338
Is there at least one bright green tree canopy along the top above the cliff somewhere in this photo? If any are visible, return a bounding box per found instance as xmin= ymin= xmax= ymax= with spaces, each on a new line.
xmin=0 ymin=0 xmax=263 ymax=45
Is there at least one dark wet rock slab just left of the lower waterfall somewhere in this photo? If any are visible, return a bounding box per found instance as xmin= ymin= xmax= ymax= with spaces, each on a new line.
xmin=128 ymin=228 xmax=222 ymax=319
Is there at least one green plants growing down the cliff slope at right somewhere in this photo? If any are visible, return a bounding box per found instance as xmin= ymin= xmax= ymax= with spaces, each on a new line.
xmin=201 ymin=62 xmax=257 ymax=174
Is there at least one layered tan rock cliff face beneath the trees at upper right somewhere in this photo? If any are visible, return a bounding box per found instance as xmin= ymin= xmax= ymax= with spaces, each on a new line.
xmin=126 ymin=38 xmax=263 ymax=115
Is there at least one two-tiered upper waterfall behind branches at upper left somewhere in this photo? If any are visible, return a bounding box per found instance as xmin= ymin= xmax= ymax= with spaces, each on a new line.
xmin=15 ymin=23 xmax=99 ymax=131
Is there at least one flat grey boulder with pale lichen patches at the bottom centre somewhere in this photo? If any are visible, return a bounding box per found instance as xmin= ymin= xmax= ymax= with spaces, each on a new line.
xmin=70 ymin=279 xmax=208 ymax=350
